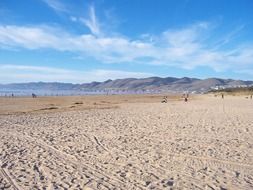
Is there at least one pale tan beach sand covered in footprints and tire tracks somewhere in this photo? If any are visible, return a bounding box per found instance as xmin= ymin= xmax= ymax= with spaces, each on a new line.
xmin=0 ymin=96 xmax=253 ymax=190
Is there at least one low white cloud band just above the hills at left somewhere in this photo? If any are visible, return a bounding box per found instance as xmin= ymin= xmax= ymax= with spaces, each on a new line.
xmin=0 ymin=65 xmax=153 ymax=83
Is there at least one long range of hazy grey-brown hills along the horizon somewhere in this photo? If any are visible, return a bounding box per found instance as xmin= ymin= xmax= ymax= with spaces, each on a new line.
xmin=0 ymin=77 xmax=253 ymax=93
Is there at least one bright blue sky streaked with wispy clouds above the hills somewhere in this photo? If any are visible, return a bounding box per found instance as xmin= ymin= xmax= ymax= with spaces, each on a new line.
xmin=0 ymin=0 xmax=253 ymax=83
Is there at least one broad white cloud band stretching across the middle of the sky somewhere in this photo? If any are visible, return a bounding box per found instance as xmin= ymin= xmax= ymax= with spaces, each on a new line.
xmin=0 ymin=21 xmax=253 ymax=71
